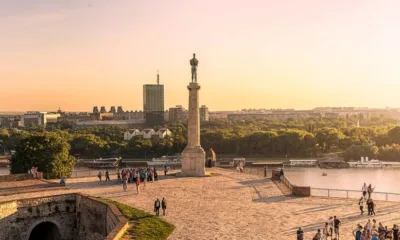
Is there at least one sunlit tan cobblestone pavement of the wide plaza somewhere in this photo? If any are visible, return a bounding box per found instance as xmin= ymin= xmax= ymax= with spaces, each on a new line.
xmin=2 ymin=169 xmax=400 ymax=240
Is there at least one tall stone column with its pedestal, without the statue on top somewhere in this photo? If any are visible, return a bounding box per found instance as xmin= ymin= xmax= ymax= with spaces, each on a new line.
xmin=181 ymin=82 xmax=206 ymax=177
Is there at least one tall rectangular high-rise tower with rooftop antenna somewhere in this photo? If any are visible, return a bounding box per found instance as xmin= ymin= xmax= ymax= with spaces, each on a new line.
xmin=143 ymin=73 xmax=164 ymax=124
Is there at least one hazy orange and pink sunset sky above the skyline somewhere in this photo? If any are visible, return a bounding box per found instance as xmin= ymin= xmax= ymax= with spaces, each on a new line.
xmin=0 ymin=0 xmax=400 ymax=111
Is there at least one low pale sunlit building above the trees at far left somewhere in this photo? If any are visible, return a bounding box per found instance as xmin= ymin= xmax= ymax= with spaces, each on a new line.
xmin=21 ymin=112 xmax=61 ymax=127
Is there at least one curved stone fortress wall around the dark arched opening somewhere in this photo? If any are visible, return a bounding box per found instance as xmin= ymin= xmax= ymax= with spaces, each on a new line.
xmin=0 ymin=194 xmax=128 ymax=240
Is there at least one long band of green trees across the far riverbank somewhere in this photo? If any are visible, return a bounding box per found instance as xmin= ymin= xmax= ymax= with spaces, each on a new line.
xmin=0 ymin=116 xmax=400 ymax=161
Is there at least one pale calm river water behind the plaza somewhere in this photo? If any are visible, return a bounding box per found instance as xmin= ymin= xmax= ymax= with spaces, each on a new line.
xmin=0 ymin=168 xmax=400 ymax=193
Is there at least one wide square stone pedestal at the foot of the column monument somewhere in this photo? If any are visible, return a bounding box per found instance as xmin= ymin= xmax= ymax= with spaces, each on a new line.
xmin=179 ymin=146 xmax=207 ymax=177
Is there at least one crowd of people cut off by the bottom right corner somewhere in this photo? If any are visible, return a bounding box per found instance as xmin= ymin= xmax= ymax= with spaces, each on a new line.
xmin=353 ymin=219 xmax=400 ymax=240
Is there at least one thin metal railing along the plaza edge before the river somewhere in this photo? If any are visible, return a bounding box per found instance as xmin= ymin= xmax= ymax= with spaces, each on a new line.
xmin=311 ymin=188 xmax=400 ymax=202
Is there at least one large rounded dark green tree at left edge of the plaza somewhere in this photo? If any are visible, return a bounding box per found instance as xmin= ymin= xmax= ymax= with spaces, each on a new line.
xmin=11 ymin=133 xmax=75 ymax=178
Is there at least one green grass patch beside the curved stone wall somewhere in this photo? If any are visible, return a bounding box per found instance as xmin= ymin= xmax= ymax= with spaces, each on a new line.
xmin=98 ymin=197 xmax=175 ymax=240
